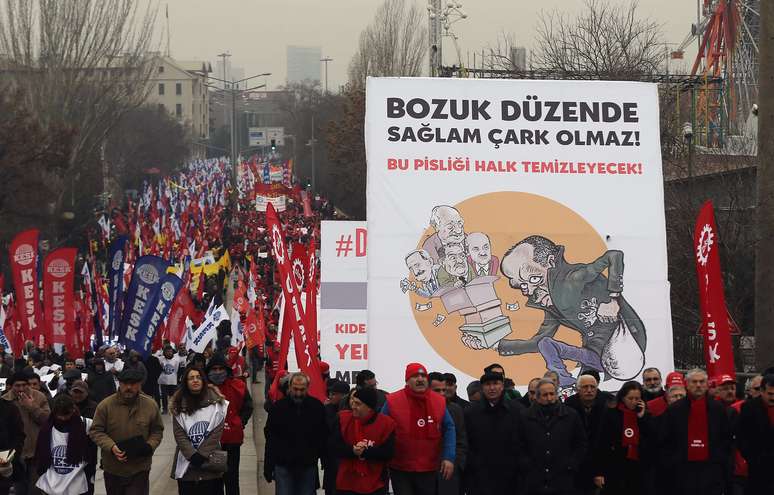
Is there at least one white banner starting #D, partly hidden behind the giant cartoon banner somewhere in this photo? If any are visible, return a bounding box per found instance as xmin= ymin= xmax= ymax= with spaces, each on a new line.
xmin=319 ymin=222 xmax=368 ymax=384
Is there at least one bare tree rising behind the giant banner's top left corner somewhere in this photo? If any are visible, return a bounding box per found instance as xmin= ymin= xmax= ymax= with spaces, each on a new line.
xmin=349 ymin=0 xmax=427 ymax=86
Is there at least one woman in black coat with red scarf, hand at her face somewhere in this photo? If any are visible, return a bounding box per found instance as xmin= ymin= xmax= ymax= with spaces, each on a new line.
xmin=592 ymin=381 xmax=655 ymax=495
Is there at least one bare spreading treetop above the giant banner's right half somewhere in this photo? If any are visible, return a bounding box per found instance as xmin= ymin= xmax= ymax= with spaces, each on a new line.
xmin=532 ymin=0 xmax=664 ymax=80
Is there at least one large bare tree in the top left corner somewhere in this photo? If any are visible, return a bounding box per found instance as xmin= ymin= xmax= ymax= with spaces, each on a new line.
xmin=0 ymin=0 xmax=156 ymax=207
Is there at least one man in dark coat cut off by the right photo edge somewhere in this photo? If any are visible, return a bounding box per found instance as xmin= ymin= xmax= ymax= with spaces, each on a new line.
xmin=737 ymin=375 xmax=774 ymax=495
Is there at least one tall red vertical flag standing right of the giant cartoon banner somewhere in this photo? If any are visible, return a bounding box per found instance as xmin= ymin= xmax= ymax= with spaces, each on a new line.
xmin=693 ymin=201 xmax=736 ymax=378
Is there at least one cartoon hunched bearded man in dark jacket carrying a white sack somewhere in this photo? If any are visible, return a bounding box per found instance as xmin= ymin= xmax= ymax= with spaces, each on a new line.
xmin=460 ymin=235 xmax=647 ymax=388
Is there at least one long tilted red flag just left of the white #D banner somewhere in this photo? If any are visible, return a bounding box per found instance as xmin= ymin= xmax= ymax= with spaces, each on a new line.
xmin=266 ymin=203 xmax=326 ymax=401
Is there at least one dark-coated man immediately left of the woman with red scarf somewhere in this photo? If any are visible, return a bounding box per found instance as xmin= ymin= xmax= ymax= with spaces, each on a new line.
xmin=564 ymin=375 xmax=607 ymax=494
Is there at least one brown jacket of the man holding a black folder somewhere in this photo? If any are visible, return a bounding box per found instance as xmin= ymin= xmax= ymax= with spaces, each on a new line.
xmin=89 ymin=392 xmax=164 ymax=476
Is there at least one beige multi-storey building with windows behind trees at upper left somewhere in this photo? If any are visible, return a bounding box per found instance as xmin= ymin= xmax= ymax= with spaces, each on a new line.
xmin=148 ymin=56 xmax=212 ymax=156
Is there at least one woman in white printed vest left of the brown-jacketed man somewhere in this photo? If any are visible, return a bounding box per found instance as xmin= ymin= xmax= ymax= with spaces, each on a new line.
xmin=35 ymin=394 xmax=97 ymax=495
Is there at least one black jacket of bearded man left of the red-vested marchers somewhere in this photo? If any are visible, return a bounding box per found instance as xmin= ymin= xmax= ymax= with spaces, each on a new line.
xmin=264 ymin=396 xmax=328 ymax=473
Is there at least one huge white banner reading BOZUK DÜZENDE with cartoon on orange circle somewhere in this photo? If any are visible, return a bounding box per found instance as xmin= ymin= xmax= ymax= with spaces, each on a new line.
xmin=366 ymin=78 xmax=673 ymax=396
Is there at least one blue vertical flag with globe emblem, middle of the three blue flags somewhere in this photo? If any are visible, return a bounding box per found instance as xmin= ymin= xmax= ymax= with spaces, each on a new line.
xmin=118 ymin=256 xmax=170 ymax=351
